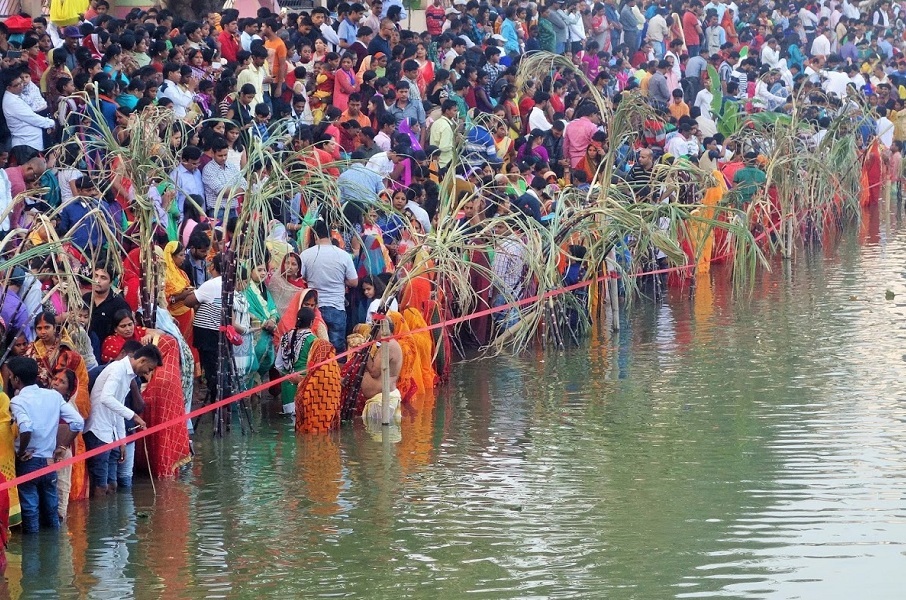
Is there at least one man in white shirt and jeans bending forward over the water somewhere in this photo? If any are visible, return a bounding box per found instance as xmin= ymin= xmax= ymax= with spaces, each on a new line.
xmin=83 ymin=344 xmax=163 ymax=496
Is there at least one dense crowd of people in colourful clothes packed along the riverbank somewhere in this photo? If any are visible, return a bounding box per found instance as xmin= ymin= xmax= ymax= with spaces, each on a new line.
xmin=0 ymin=0 xmax=906 ymax=544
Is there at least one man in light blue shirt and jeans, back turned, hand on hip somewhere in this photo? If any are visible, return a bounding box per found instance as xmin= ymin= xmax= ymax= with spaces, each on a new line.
xmin=2 ymin=356 xmax=85 ymax=533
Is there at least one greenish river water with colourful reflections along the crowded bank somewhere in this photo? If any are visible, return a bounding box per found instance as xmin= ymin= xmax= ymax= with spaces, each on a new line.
xmin=7 ymin=209 xmax=906 ymax=600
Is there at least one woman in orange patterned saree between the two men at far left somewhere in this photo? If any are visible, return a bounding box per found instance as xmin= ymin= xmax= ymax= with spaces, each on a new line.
xmin=25 ymin=312 xmax=91 ymax=501
